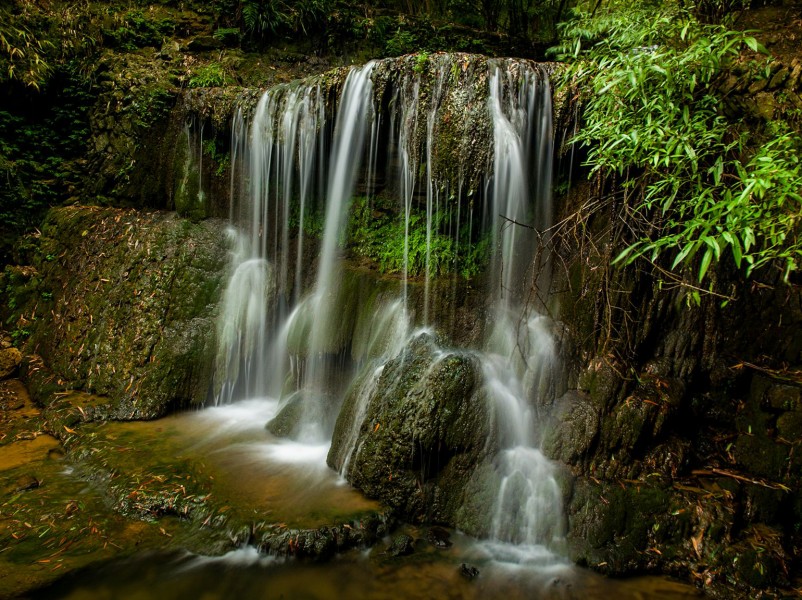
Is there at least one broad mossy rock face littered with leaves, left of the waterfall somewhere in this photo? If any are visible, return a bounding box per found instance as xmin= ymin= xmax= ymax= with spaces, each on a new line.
xmin=2 ymin=207 xmax=227 ymax=419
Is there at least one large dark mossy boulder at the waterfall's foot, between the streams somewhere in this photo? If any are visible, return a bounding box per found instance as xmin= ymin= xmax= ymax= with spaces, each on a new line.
xmin=328 ymin=334 xmax=494 ymax=532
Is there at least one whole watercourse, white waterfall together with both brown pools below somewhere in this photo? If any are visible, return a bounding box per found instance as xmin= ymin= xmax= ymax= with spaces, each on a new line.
xmin=29 ymin=55 xmax=695 ymax=598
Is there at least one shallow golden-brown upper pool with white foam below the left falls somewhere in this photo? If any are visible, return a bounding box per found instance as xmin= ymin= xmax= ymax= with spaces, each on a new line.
xmin=92 ymin=400 xmax=380 ymax=529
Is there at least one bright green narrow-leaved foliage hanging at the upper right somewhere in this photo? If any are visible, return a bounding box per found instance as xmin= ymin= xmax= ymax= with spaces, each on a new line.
xmin=557 ymin=3 xmax=802 ymax=281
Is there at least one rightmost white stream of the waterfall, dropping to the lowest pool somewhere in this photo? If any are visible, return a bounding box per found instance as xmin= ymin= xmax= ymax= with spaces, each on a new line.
xmin=484 ymin=66 xmax=564 ymax=546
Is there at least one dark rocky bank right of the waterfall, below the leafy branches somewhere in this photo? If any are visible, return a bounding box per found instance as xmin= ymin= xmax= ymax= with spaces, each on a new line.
xmin=544 ymin=178 xmax=802 ymax=597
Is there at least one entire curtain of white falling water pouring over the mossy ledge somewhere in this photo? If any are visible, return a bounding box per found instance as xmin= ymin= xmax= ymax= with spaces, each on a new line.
xmin=212 ymin=55 xmax=562 ymax=546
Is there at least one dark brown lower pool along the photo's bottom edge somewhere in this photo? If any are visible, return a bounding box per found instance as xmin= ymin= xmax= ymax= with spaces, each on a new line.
xmin=32 ymin=536 xmax=699 ymax=600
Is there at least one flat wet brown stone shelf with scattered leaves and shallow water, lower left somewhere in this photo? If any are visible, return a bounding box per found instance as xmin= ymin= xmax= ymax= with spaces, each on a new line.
xmin=0 ymin=380 xmax=388 ymax=597
